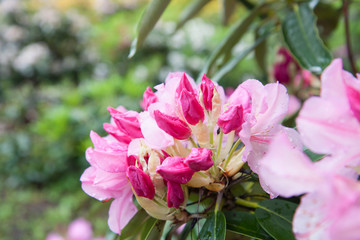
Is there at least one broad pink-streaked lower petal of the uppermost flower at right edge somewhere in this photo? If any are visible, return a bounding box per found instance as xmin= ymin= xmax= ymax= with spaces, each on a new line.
xmin=296 ymin=97 xmax=360 ymax=154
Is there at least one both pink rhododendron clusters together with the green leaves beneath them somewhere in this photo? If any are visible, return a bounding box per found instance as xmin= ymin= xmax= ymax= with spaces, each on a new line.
xmin=81 ymin=59 xmax=360 ymax=239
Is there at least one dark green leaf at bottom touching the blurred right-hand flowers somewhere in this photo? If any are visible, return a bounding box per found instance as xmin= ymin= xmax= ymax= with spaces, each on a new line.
xmin=255 ymin=199 xmax=297 ymax=240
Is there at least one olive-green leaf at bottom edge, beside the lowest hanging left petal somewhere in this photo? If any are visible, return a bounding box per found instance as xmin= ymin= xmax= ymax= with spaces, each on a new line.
xmin=120 ymin=209 xmax=151 ymax=240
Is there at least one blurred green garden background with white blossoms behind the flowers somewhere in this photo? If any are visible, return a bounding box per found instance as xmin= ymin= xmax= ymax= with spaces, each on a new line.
xmin=0 ymin=0 xmax=360 ymax=239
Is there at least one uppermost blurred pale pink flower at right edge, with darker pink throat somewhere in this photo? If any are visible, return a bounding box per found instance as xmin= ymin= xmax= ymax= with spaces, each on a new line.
xmin=296 ymin=59 xmax=360 ymax=170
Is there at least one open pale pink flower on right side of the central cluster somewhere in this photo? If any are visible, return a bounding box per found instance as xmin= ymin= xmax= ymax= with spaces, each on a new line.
xmin=239 ymin=80 xmax=289 ymax=172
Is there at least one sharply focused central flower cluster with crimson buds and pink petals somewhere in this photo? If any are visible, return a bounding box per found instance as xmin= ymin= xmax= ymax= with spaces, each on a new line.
xmin=81 ymin=73 xmax=295 ymax=233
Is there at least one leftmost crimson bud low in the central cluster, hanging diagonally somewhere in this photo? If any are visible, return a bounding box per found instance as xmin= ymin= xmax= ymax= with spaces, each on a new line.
xmin=126 ymin=166 xmax=155 ymax=199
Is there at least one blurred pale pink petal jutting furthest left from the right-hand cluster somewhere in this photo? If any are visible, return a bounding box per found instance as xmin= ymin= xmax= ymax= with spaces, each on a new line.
xmin=258 ymin=132 xmax=321 ymax=197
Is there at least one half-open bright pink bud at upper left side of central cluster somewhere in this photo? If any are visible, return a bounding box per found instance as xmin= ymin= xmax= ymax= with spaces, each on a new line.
xmin=108 ymin=107 xmax=143 ymax=138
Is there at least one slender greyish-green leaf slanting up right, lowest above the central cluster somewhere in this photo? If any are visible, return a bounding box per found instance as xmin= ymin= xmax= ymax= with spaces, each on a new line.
xmin=211 ymin=30 xmax=268 ymax=82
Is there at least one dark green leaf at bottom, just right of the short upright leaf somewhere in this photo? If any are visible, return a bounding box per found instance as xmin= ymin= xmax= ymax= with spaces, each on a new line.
xmin=224 ymin=211 xmax=272 ymax=239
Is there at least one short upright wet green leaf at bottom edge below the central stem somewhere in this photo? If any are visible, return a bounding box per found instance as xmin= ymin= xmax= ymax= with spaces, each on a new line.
xmin=199 ymin=211 xmax=226 ymax=240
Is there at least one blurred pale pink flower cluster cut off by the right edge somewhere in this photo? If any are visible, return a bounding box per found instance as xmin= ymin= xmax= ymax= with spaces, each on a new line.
xmin=259 ymin=59 xmax=360 ymax=240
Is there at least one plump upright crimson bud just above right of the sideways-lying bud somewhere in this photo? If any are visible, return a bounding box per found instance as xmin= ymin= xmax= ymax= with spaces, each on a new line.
xmin=180 ymin=89 xmax=204 ymax=125
